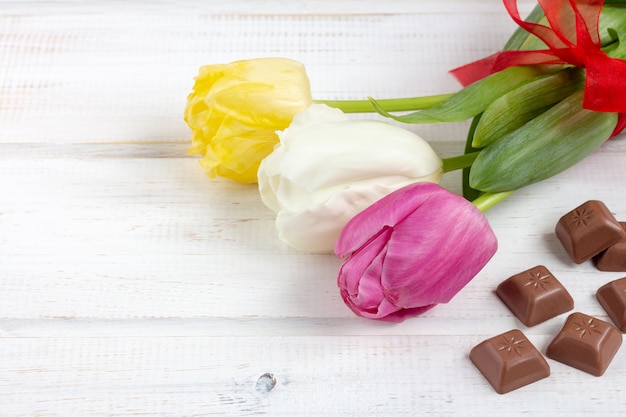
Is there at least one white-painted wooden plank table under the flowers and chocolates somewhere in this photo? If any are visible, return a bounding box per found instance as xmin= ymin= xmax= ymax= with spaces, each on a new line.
xmin=0 ymin=0 xmax=626 ymax=417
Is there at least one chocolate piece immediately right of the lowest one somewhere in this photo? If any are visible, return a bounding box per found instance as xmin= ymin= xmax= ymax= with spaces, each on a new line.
xmin=546 ymin=313 xmax=622 ymax=376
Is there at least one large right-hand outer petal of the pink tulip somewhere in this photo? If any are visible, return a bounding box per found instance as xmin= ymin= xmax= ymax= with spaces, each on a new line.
xmin=382 ymin=193 xmax=497 ymax=308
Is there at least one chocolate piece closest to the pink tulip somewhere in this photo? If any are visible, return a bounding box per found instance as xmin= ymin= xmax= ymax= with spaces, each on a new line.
xmin=496 ymin=265 xmax=574 ymax=327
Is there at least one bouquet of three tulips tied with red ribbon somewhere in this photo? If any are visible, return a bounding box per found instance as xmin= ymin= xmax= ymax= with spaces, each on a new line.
xmin=185 ymin=0 xmax=626 ymax=321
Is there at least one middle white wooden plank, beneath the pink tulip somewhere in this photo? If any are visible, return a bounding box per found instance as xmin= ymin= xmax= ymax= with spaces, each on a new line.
xmin=0 ymin=140 xmax=626 ymax=324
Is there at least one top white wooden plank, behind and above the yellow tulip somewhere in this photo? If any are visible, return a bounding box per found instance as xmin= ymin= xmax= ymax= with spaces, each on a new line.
xmin=0 ymin=1 xmax=528 ymax=143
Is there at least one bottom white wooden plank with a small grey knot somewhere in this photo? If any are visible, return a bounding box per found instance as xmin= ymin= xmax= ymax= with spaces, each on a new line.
xmin=0 ymin=336 xmax=626 ymax=416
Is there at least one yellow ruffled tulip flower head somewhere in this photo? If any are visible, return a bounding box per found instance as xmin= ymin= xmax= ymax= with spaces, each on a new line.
xmin=185 ymin=58 xmax=312 ymax=183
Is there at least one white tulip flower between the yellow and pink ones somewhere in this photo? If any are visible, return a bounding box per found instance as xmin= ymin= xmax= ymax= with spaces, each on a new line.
xmin=258 ymin=104 xmax=442 ymax=252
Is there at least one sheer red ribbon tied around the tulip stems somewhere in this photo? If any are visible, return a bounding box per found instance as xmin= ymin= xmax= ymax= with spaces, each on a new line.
xmin=451 ymin=0 xmax=626 ymax=135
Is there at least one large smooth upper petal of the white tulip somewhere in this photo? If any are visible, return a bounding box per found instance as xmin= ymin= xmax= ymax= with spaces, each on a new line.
xmin=281 ymin=118 xmax=441 ymax=192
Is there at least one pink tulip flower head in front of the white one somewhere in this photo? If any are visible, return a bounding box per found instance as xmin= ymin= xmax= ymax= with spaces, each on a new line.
xmin=335 ymin=182 xmax=498 ymax=322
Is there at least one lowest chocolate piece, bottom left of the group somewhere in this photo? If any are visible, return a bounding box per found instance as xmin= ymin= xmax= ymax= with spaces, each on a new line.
xmin=469 ymin=329 xmax=550 ymax=394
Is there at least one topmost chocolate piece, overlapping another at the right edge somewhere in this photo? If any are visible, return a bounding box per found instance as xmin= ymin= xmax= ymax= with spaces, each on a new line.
xmin=555 ymin=200 xmax=626 ymax=264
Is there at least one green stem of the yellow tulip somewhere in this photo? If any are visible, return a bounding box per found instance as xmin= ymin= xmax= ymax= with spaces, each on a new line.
xmin=314 ymin=94 xmax=452 ymax=113
